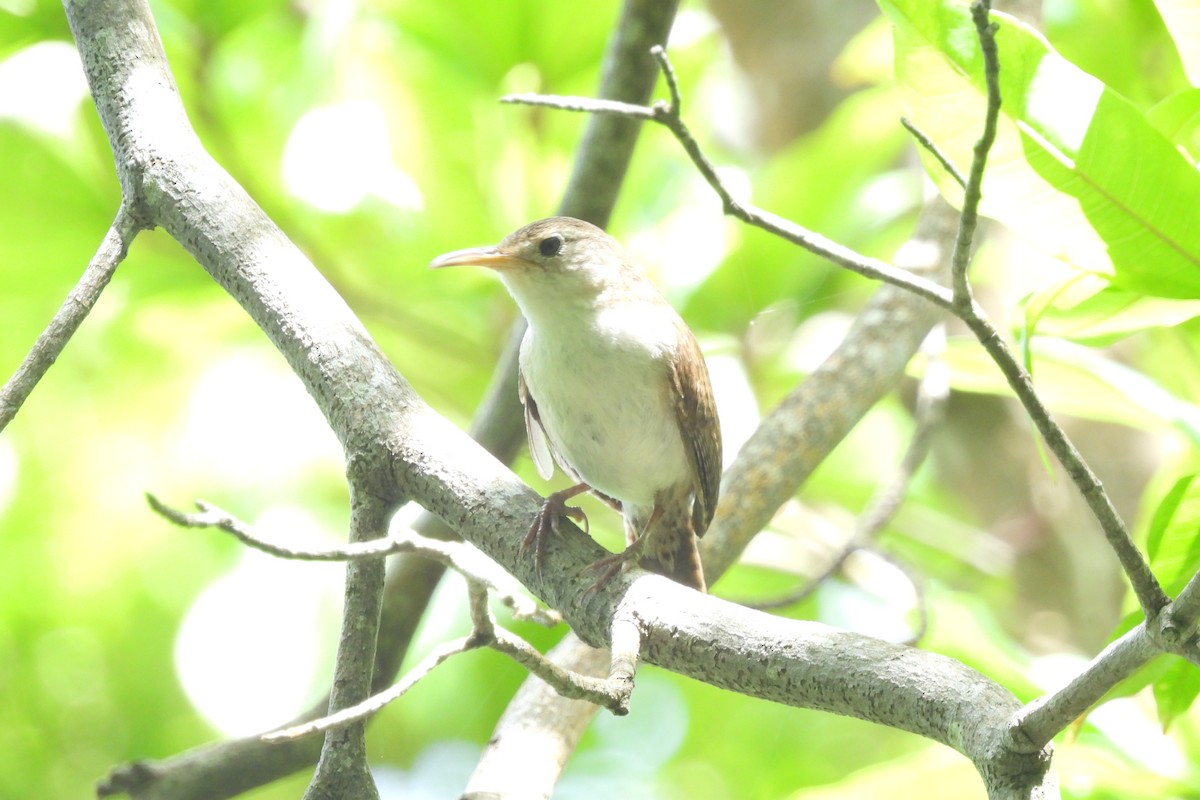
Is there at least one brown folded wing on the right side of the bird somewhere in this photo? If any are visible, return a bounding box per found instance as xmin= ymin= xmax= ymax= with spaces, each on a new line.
xmin=670 ymin=320 xmax=721 ymax=536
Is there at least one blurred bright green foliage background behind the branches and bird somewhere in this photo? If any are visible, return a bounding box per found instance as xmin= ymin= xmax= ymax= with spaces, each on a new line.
xmin=0 ymin=0 xmax=1200 ymax=800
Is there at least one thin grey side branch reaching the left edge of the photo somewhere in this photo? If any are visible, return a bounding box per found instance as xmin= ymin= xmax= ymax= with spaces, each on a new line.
xmin=0 ymin=205 xmax=146 ymax=431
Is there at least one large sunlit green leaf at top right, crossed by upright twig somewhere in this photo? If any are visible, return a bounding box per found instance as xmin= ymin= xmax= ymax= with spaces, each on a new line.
xmin=878 ymin=0 xmax=1200 ymax=297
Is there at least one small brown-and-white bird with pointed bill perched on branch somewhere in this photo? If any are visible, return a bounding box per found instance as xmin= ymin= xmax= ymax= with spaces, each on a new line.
xmin=430 ymin=217 xmax=721 ymax=591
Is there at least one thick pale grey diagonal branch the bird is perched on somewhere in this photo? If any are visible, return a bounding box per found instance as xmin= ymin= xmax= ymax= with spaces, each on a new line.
xmin=58 ymin=0 xmax=1099 ymax=787
